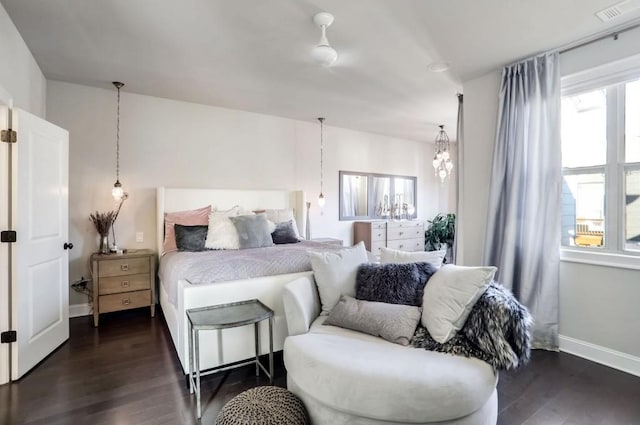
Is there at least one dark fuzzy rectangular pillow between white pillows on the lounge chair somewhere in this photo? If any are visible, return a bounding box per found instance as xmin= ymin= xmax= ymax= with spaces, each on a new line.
xmin=356 ymin=263 xmax=436 ymax=306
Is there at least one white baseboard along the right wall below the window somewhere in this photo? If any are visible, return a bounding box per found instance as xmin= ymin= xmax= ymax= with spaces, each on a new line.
xmin=560 ymin=335 xmax=640 ymax=376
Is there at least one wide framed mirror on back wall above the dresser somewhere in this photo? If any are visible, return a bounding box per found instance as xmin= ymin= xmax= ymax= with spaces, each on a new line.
xmin=339 ymin=171 xmax=417 ymax=220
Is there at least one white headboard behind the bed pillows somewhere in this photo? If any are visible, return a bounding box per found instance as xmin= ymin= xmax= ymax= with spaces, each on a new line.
xmin=156 ymin=187 xmax=306 ymax=255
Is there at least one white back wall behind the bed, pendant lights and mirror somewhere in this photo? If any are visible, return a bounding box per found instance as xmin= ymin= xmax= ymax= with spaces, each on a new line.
xmin=47 ymin=81 xmax=449 ymax=304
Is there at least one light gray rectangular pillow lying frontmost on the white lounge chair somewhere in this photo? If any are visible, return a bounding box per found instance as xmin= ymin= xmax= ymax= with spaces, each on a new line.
xmin=324 ymin=295 xmax=422 ymax=345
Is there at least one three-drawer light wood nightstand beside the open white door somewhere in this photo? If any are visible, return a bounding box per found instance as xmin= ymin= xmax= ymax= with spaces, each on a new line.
xmin=91 ymin=249 xmax=156 ymax=327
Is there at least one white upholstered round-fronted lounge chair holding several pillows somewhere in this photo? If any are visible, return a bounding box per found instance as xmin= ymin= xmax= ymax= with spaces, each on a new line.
xmin=283 ymin=276 xmax=498 ymax=425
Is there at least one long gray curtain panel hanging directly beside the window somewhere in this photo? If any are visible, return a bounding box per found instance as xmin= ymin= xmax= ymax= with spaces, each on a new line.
xmin=484 ymin=53 xmax=562 ymax=350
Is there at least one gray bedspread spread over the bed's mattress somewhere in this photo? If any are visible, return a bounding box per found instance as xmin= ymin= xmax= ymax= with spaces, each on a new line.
xmin=158 ymin=241 xmax=342 ymax=305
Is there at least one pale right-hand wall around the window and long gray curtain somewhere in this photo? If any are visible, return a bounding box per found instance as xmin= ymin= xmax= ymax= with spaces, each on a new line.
xmin=463 ymin=25 xmax=640 ymax=368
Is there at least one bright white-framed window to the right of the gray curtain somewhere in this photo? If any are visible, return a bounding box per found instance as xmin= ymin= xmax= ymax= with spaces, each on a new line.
xmin=561 ymin=76 xmax=640 ymax=254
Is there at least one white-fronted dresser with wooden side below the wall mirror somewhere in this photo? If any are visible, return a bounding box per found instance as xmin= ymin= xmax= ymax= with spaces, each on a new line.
xmin=353 ymin=220 xmax=424 ymax=256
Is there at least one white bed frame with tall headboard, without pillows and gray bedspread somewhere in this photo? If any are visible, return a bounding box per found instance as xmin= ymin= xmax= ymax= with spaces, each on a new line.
xmin=156 ymin=187 xmax=338 ymax=374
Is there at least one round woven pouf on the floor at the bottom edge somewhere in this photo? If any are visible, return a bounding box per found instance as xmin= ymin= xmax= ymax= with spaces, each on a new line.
xmin=216 ymin=386 xmax=309 ymax=425
